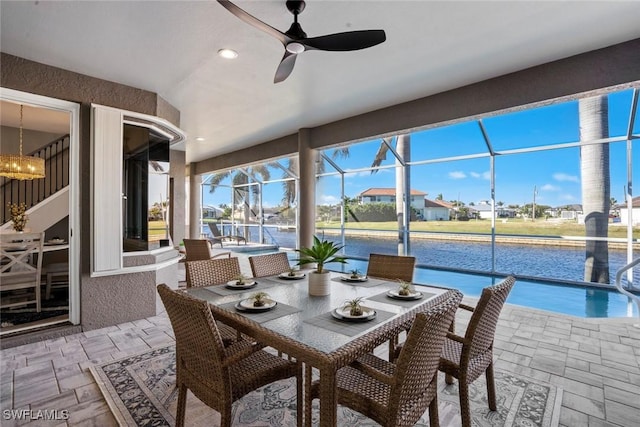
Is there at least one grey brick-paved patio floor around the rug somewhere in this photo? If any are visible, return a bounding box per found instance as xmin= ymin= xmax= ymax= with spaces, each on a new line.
xmin=0 ymin=264 xmax=640 ymax=427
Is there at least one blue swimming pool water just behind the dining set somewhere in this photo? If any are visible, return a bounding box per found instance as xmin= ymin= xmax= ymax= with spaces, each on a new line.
xmin=332 ymin=259 xmax=638 ymax=317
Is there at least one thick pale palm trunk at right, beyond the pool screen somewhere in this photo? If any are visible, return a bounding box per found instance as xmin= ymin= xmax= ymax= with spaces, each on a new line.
xmin=578 ymin=96 xmax=611 ymax=283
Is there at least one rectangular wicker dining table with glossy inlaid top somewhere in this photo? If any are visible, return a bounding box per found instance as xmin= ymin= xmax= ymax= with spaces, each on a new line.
xmin=186 ymin=272 xmax=457 ymax=426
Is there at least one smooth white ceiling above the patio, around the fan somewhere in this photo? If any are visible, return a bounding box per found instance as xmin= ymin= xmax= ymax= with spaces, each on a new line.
xmin=0 ymin=0 xmax=640 ymax=161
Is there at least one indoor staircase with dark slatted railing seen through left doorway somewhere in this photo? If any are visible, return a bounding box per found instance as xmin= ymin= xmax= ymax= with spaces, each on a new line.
xmin=0 ymin=135 xmax=69 ymax=232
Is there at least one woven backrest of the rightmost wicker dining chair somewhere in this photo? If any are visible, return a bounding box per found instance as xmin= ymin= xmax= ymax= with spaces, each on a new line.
xmin=461 ymin=276 xmax=516 ymax=364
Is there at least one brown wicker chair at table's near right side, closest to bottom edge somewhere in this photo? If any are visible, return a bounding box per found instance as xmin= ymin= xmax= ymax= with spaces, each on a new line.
xmin=305 ymin=291 xmax=462 ymax=427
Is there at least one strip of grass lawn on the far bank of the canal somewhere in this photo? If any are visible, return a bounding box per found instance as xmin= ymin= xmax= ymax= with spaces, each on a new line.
xmin=316 ymin=218 xmax=640 ymax=239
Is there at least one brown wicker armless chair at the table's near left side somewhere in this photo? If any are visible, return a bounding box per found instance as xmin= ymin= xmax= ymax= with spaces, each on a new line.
xmin=158 ymin=284 xmax=303 ymax=427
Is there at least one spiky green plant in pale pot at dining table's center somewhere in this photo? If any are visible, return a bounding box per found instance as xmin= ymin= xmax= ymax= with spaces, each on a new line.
xmin=296 ymin=236 xmax=347 ymax=296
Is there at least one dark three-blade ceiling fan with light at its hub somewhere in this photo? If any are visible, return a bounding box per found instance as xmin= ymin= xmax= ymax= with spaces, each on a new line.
xmin=218 ymin=0 xmax=386 ymax=83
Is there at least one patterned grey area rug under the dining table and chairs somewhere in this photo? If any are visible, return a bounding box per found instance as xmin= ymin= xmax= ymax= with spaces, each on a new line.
xmin=91 ymin=346 xmax=562 ymax=427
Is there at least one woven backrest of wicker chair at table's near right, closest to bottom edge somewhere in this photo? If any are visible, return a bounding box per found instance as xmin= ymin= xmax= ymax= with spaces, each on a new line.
xmin=389 ymin=291 xmax=462 ymax=425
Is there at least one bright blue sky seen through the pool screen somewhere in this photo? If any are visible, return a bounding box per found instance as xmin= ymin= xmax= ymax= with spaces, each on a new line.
xmin=204 ymin=90 xmax=640 ymax=207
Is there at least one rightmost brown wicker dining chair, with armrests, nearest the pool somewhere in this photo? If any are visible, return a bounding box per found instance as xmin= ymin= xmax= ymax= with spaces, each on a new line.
xmin=439 ymin=276 xmax=516 ymax=427
